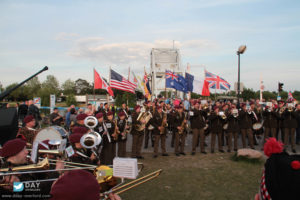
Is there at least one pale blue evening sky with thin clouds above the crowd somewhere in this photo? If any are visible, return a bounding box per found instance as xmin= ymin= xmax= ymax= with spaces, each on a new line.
xmin=0 ymin=0 xmax=300 ymax=91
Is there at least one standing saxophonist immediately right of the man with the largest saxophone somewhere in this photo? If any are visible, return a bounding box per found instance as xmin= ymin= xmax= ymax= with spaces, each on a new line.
xmin=151 ymin=106 xmax=168 ymax=158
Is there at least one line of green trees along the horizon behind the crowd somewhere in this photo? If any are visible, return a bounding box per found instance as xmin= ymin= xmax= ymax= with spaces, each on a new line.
xmin=0 ymin=75 xmax=300 ymax=106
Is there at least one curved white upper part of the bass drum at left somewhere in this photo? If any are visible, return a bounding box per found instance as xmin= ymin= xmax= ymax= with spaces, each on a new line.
xmin=34 ymin=126 xmax=68 ymax=142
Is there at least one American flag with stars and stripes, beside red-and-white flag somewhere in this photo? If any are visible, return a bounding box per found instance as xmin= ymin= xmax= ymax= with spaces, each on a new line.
xmin=110 ymin=69 xmax=137 ymax=94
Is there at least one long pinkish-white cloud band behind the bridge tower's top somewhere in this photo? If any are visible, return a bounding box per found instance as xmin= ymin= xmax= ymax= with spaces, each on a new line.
xmin=68 ymin=37 xmax=218 ymax=66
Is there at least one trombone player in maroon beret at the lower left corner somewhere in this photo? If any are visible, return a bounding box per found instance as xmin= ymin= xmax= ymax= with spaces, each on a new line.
xmin=0 ymin=138 xmax=64 ymax=195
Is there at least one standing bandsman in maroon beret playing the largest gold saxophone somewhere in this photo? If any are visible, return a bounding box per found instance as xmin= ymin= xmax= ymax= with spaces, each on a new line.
xmin=131 ymin=105 xmax=146 ymax=159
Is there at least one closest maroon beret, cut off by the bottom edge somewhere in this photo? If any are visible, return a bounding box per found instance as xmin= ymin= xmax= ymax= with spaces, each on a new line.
xmin=50 ymin=170 xmax=99 ymax=200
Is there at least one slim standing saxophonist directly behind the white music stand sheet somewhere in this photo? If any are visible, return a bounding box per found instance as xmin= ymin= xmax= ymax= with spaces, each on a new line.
xmin=117 ymin=111 xmax=129 ymax=157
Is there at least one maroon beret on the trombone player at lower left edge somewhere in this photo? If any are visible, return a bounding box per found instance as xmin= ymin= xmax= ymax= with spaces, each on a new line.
xmin=0 ymin=138 xmax=26 ymax=158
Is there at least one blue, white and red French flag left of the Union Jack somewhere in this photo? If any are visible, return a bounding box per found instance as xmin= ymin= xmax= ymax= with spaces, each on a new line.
xmin=185 ymin=73 xmax=210 ymax=96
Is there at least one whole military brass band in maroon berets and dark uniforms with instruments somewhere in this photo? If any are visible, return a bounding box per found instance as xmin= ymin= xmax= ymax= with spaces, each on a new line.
xmin=0 ymin=97 xmax=300 ymax=198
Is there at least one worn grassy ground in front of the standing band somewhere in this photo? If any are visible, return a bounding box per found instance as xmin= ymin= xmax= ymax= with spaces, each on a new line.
xmin=120 ymin=153 xmax=264 ymax=200
